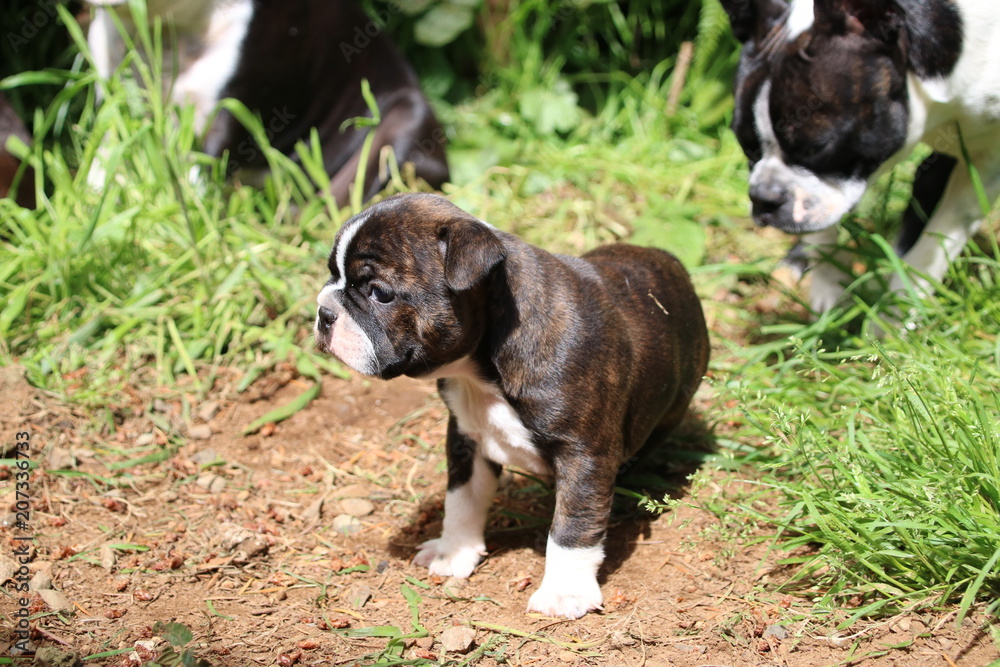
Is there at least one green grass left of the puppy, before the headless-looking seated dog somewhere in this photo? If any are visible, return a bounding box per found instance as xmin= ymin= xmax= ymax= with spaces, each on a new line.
xmin=0 ymin=5 xmax=347 ymax=404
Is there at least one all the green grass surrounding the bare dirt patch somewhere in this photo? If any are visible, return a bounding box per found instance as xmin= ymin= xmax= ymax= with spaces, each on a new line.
xmin=0 ymin=2 xmax=1000 ymax=640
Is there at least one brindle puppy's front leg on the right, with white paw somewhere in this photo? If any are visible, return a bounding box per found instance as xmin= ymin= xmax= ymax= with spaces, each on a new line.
xmin=528 ymin=456 xmax=617 ymax=618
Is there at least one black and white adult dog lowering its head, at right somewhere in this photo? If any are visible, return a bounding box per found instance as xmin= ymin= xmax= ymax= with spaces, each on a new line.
xmin=722 ymin=0 xmax=1000 ymax=312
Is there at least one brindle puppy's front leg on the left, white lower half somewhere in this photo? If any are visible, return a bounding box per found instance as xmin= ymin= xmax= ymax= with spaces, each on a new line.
xmin=413 ymin=417 xmax=500 ymax=578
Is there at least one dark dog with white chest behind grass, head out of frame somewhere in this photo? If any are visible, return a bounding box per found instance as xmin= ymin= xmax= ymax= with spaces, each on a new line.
xmin=82 ymin=0 xmax=448 ymax=205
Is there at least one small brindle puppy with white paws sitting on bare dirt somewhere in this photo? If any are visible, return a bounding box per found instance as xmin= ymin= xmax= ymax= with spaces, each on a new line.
xmin=315 ymin=195 xmax=709 ymax=618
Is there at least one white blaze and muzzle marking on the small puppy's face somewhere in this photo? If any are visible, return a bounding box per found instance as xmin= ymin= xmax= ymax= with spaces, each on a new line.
xmin=313 ymin=216 xmax=379 ymax=375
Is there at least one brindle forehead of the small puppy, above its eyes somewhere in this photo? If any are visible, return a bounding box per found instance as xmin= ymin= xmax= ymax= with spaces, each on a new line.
xmin=327 ymin=195 xmax=471 ymax=289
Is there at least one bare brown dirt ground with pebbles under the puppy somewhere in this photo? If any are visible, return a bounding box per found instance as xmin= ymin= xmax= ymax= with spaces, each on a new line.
xmin=0 ymin=360 xmax=1000 ymax=667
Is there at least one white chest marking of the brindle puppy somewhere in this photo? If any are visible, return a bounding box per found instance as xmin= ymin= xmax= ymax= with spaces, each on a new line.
xmin=444 ymin=376 xmax=550 ymax=475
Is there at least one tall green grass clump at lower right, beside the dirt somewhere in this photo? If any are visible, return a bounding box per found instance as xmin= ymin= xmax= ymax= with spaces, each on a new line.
xmin=712 ymin=268 xmax=1000 ymax=620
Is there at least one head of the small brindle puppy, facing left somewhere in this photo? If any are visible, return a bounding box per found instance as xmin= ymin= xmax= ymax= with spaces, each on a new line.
xmin=315 ymin=195 xmax=505 ymax=379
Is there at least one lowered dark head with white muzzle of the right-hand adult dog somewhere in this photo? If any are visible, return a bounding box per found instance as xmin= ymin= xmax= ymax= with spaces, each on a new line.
xmin=723 ymin=0 xmax=949 ymax=234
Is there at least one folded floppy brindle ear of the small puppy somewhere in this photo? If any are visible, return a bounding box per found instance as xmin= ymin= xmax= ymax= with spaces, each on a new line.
xmin=437 ymin=218 xmax=507 ymax=292
